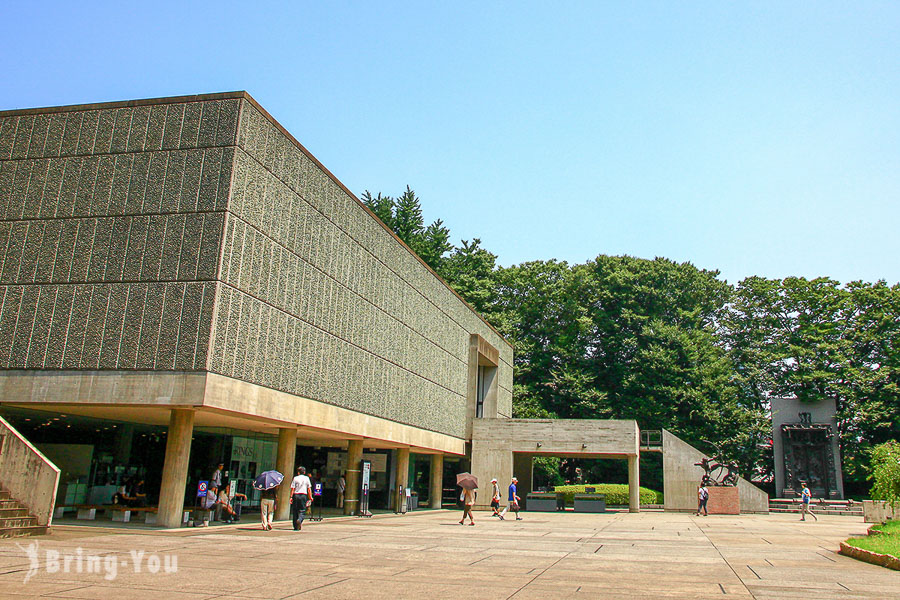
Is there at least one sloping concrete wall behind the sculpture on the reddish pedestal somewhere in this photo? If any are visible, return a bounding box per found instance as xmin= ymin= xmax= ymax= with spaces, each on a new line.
xmin=663 ymin=430 xmax=769 ymax=513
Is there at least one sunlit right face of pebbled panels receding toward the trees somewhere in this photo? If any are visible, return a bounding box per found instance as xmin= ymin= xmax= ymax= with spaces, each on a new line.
xmin=201 ymin=101 xmax=512 ymax=437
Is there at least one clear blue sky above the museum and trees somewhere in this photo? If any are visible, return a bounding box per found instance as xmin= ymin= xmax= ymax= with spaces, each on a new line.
xmin=0 ymin=1 xmax=900 ymax=283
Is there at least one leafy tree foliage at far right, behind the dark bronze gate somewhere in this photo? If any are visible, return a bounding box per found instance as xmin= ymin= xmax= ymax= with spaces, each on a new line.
xmin=723 ymin=277 xmax=900 ymax=481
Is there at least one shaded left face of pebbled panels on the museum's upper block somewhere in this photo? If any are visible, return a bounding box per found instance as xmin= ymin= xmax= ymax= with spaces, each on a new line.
xmin=0 ymin=98 xmax=240 ymax=370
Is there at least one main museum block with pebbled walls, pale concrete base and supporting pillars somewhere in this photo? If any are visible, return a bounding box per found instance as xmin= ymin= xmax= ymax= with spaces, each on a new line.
xmin=0 ymin=92 xmax=512 ymax=525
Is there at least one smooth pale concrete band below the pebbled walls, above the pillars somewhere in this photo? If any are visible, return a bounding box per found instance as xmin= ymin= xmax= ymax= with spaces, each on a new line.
xmin=0 ymin=371 xmax=466 ymax=456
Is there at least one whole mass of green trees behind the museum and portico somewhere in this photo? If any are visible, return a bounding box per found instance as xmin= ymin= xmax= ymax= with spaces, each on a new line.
xmin=362 ymin=187 xmax=900 ymax=488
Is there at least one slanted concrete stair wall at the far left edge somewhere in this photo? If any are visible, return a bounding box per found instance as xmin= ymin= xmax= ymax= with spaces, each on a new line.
xmin=0 ymin=417 xmax=59 ymax=525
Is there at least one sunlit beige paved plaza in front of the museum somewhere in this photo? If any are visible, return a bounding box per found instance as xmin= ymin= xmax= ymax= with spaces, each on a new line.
xmin=0 ymin=511 xmax=900 ymax=600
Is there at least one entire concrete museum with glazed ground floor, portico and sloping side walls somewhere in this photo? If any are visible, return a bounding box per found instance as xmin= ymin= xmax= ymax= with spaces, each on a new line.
xmin=0 ymin=92 xmax=767 ymax=533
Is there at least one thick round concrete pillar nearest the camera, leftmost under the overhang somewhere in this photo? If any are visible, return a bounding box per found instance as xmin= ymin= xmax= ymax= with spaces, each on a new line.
xmin=156 ymin=408 xmax=194 ymax=527
